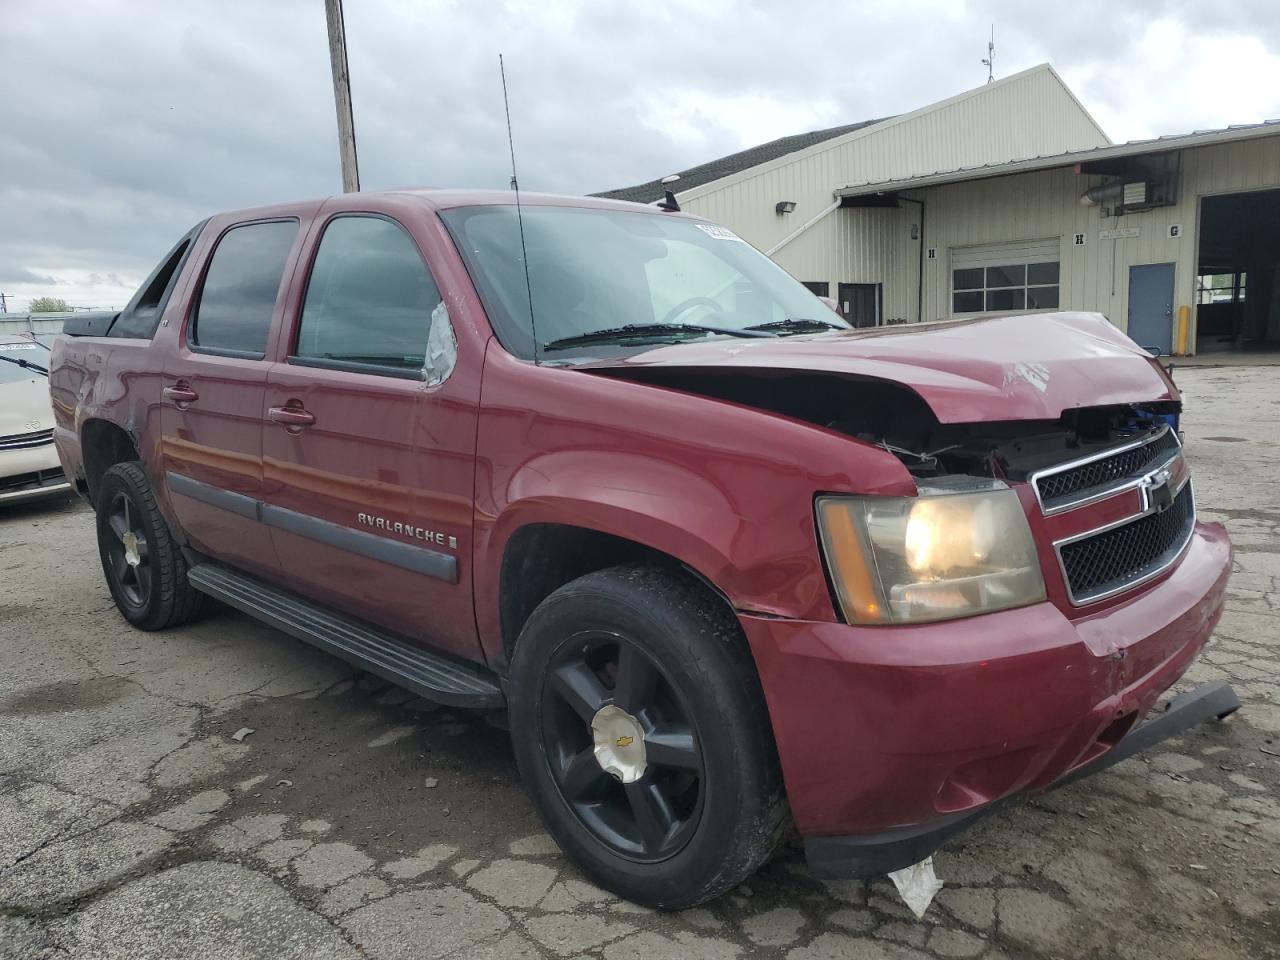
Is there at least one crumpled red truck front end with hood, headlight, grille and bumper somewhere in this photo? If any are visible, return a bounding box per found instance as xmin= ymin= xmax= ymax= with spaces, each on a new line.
xmin=589 ymin=317 xmax=1239 ymax=909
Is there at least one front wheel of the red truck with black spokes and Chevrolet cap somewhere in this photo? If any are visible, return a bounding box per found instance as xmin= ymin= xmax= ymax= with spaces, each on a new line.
xmin=509 ymin=567 xmax=786 ymax=909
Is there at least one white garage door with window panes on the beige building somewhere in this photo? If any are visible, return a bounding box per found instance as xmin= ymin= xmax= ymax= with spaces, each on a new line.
xmin=951 ymin=237 xmax=1062 ymax=314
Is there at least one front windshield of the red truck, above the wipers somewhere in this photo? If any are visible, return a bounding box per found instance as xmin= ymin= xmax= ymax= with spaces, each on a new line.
xmin=440 ymin=205 xmax=847 ymax=360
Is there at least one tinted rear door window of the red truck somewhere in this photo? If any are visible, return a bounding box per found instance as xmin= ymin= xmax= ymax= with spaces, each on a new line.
xmin=191 ymin=220 xmax=298 ymax=356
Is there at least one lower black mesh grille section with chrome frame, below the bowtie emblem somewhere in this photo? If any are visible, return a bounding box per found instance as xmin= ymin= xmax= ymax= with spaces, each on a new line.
xmin=1057 ymin=483 xmax=1196 ymax=604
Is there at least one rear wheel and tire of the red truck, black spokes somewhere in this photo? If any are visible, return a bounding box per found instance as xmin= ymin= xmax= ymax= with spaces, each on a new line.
xmin=96 ymin=462 xmax=212 ymax=630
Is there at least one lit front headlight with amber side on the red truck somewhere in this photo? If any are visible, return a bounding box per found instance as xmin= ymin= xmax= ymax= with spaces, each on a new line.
xmin=818 ymin=477 xmax=1044 ymax=623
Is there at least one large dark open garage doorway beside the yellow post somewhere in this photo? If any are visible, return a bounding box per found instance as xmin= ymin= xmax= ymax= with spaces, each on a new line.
xmin=1196 ymin=189 xmax=1280 ymax=353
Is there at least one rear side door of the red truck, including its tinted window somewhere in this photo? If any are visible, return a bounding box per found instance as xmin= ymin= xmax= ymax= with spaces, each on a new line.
xmin=160 ymin=219 xmax=298 ymax=575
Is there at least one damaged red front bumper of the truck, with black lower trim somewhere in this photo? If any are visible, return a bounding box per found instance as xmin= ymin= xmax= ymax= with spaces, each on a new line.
xmin=741 ymin=524 xmax=1234 ymax=876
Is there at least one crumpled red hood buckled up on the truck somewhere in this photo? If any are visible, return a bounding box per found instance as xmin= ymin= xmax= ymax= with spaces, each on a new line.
xmin=579 ymin=312 xmax=1178 ymax=424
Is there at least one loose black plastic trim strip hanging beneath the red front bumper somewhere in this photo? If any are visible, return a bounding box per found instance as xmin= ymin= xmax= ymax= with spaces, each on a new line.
xmin=804 ymin=681 xmax=1240 ymax=879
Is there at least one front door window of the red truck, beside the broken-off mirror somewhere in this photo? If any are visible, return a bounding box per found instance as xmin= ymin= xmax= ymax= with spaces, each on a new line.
xmin=293 ymin=216 xmax=447 ymax=372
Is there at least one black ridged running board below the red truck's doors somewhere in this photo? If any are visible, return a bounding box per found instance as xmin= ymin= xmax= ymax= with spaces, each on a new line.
xmin=187 ymin=563 xmax=507 ymax=709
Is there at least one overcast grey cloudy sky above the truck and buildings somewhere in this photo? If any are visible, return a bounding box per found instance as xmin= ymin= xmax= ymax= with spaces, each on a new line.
xmin=0 ymin=0 xmax=1280 ymax=310
